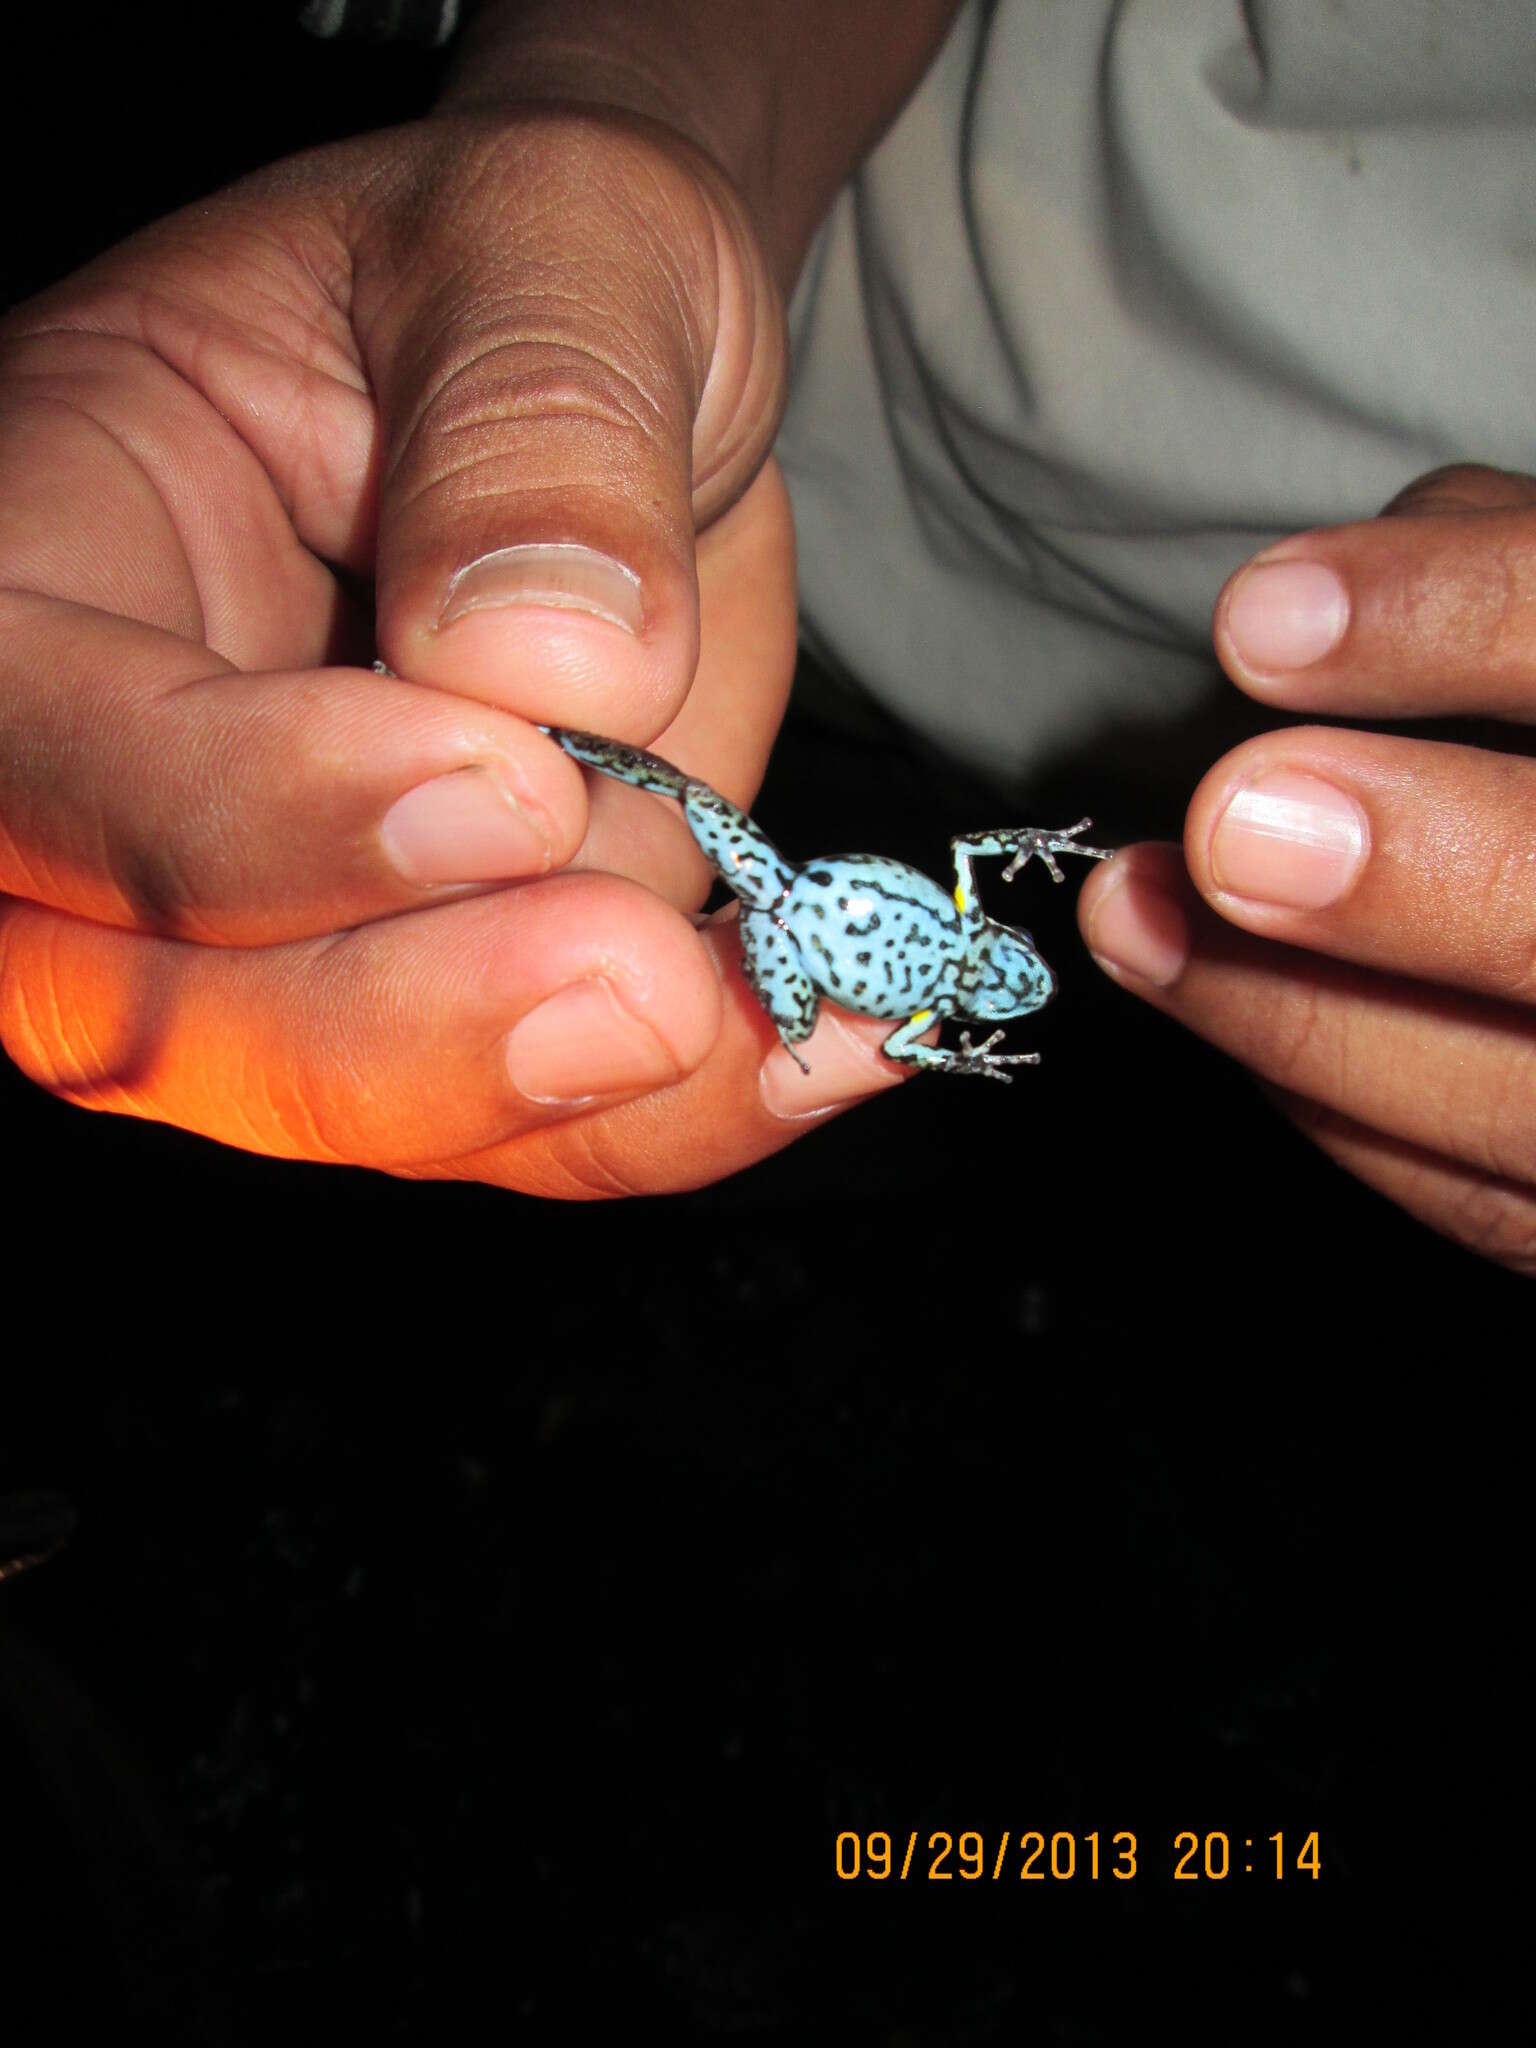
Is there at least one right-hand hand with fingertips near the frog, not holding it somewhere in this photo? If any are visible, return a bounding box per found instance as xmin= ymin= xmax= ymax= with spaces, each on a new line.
xmin=1079 ymin=467 xmax=1536 ymax=1272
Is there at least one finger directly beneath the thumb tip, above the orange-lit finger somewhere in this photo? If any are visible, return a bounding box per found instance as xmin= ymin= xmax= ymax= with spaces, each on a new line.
xmin=0 ymin=594 xmax=586 ymax=946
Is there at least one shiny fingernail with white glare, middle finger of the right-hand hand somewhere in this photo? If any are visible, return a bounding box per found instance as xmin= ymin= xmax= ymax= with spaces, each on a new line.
xmin=1210 ymin=768 xmax=1370 ymax=909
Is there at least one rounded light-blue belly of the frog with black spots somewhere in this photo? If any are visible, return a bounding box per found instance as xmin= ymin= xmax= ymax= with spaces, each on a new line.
xmin=778 ymin=854 xmax=961 ymax=1020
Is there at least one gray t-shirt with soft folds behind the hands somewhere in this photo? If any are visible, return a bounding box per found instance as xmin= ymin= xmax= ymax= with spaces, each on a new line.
xmin=778 ymin=0 xmax=1536 ymax=776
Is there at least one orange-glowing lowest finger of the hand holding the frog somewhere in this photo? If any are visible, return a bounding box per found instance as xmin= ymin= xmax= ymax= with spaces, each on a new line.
xmin=0 ymin=877 xmax=905 ymax=1196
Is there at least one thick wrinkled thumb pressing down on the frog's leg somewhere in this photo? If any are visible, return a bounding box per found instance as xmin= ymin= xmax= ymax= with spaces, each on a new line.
xmin=356 ymin=115 xmax=782 ymax=739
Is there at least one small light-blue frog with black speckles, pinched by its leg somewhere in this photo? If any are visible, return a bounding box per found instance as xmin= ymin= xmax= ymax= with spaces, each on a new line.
xmin=539 ymin=725 xmax=1112 ymax=1081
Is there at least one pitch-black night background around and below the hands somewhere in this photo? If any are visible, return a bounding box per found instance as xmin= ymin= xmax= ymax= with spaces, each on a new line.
xmin=0 ymin=8 xmax=1532 ymax=2048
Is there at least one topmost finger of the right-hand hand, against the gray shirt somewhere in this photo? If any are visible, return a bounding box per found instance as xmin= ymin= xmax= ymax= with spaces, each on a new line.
xmin=1212 ymin=479 xmax=1536 ymax=719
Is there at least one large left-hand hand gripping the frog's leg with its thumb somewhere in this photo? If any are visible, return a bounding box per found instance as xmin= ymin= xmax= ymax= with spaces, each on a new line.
xmin=0 ymin=109 xmax=921 ymax=1194
